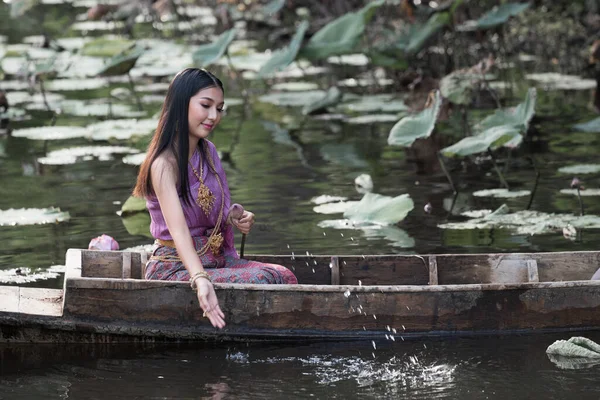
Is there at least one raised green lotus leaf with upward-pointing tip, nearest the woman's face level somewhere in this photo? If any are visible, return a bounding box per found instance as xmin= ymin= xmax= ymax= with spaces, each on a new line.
xmin=388 ymin=91 xmax=442 ymax=147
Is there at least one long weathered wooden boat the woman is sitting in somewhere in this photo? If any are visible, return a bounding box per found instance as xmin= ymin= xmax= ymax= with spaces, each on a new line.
xmin=0 ymin=249 xmax=600 ymax=343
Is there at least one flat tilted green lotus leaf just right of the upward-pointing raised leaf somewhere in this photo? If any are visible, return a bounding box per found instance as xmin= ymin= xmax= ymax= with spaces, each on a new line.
xmin=440 ymin=125 xmax=521 ymax=157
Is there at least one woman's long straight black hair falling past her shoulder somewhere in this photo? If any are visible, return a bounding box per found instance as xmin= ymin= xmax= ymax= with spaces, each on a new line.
xmin=133 ymin=68 xmax=225 ymax=203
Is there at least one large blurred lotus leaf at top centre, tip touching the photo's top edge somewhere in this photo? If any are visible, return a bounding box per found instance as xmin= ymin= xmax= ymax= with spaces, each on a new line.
xmin=300 ymin=0 xmax=385 ymax=59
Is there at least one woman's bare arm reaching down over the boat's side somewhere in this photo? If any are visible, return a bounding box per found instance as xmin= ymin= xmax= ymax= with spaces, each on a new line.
xmin=150 ymin=155 xmax=225 ymax=328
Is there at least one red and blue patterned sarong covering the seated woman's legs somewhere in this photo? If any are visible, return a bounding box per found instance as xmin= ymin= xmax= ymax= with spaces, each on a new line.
xmin=145 ymin=236 xmax=298 ymax=284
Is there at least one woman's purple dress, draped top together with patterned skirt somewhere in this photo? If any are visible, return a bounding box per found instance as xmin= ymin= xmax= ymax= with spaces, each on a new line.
xmin=145 ymin=139 xmax=298 ymax=284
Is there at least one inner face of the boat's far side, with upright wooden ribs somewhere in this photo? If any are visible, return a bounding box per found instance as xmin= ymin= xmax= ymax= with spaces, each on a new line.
xmin=81 ymin=250 xmax=600 ymax=286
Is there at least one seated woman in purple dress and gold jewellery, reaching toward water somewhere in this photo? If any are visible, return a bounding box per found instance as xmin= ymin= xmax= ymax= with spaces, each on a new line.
xmin=133 ymin=68 xmax=298 ymax=328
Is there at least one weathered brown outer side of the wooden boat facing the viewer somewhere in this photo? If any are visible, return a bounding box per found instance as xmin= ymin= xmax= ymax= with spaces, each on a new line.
xmin=59 ymin=278 xmax=600 ymax=338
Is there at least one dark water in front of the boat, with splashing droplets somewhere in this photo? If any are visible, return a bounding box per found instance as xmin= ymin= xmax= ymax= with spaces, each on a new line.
xmin=0 ymin=333 xmax=600 ymax=400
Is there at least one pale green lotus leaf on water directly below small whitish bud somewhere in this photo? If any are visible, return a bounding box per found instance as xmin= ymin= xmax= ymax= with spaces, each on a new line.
xmin=344 ymin=193 xmax=415 ymax=225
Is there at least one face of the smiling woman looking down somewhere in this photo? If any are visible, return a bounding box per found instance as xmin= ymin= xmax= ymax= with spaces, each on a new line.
xmin=188 ymin=87 xmax=225 ymax=139
